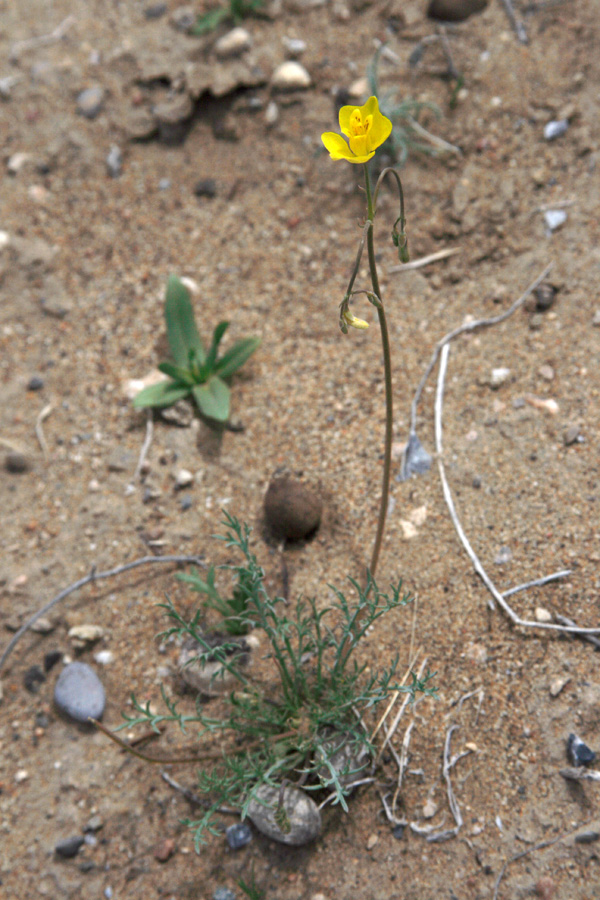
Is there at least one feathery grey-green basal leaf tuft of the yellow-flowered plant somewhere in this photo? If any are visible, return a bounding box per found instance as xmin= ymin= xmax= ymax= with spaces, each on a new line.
xmin=125 ymin=513 xmax=435 ymax=844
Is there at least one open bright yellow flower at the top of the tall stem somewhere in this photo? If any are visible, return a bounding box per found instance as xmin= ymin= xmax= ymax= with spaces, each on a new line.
xmin=321 ymin=97 xmax=392 ymax=163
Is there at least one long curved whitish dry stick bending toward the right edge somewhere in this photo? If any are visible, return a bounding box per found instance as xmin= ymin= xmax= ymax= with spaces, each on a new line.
xmin=435 ymin=344 xmax=600 ymax=634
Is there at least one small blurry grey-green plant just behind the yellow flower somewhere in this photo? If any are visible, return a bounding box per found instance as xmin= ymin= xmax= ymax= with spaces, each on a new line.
xmin=367 ymin=44 xmax=461 ymax=166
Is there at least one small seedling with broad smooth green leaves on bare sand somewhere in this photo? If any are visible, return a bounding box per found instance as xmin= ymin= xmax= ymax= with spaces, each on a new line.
xmin=133 ymin=275 xmax=260 ymax=422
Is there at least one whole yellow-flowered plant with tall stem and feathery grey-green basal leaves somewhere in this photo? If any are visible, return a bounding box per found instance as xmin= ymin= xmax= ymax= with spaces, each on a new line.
xmin=99 ymin=97 xmax=436 ymax=844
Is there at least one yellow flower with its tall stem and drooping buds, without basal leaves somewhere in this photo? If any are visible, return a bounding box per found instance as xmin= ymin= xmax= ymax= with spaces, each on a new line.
xmin=321 ymin=97 xmax=408 ymax=578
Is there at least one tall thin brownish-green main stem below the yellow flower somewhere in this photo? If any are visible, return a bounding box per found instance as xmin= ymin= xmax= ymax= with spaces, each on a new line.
xmin=365 ymin=164 xmax=393 ymax=578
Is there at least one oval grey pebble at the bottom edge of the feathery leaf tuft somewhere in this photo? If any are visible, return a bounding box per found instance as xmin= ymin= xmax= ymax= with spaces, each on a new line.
xmin=248 ymin=784 xmax=321 ymax=847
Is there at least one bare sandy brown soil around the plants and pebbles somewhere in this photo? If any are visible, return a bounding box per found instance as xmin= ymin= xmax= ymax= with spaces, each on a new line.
xmin=0 ymin=0 xmax=600 ymax=900
